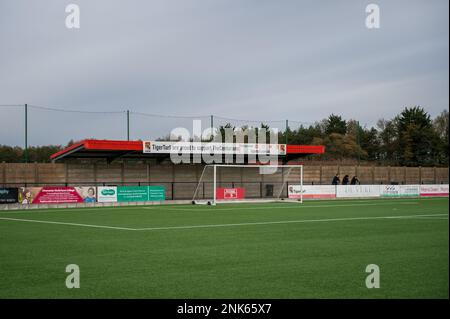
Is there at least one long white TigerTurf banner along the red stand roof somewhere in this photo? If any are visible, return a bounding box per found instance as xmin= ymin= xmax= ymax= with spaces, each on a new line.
xmin=143 ymin=141 xmax=286 ymax=155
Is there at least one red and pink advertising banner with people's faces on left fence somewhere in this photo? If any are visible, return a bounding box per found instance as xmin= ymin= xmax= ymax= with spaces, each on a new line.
xmin=18 ymin=186 xmax=96 ymax=204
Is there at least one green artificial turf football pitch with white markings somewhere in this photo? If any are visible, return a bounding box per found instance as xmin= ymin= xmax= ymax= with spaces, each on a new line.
xmin=0 ymin=198 xmax=449 ymax=298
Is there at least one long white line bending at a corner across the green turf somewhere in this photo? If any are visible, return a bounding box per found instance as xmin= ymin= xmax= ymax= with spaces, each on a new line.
xmin=0 ymin=213 xmax=448 ymax=231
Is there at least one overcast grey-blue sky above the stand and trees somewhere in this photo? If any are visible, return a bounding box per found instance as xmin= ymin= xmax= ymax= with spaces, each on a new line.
xmin=0 ymin=0 xmax=449 ymax=145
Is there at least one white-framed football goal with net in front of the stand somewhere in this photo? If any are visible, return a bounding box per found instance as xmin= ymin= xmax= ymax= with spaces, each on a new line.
xmin=192 ymin=164 xmax=303 ymax=205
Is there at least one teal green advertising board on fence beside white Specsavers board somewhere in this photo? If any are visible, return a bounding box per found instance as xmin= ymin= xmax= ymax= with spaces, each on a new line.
xmin=117 ymin=186 xmax=166 ymax=202
